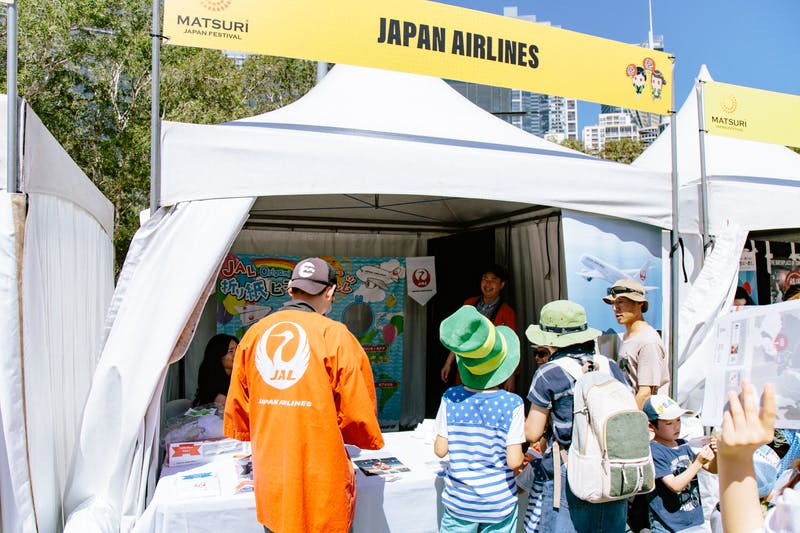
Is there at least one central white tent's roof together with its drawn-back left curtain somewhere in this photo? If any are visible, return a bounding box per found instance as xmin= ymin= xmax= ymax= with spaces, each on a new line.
xmin=65 ymin=65 xmax=671 ymax=532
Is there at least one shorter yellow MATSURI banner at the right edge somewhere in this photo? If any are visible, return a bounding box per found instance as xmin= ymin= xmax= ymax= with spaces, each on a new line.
xmin=703 ymin=81 xmax=800 ymax=146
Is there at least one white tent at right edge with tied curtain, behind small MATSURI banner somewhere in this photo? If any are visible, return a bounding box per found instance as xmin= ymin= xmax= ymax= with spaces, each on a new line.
xmin=632 ymin=66 xmax=800 ymax=410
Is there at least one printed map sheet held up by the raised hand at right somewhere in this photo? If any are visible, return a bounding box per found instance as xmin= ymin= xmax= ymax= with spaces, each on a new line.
xmin=701 ymin=300 xmax=800 ymax=429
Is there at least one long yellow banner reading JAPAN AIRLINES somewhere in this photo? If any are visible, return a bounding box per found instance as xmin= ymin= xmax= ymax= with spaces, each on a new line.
xmin=163 ymin=0 xmax=673 ymax=114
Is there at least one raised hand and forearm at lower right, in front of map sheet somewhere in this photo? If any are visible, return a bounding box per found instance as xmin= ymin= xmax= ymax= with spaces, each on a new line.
xmin=719 ymin=380 xmax=775 ymax=533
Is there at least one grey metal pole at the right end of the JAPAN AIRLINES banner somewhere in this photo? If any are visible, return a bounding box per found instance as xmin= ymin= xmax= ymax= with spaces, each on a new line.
xmin=669 ymin=57 xmax=682 ymax=398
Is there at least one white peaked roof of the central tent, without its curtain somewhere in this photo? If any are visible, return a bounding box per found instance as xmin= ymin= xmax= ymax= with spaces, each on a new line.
xmin=166 ymin=65 xmax=671 ymax=227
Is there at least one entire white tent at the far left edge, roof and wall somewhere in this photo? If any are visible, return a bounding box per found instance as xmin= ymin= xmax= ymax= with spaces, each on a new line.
xmin=0 ymin=95 xmax=114 ymax=532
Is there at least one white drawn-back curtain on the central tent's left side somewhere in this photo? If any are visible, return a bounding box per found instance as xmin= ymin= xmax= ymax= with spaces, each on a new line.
xmin=64 ymin=198 xmax=253 ymax=533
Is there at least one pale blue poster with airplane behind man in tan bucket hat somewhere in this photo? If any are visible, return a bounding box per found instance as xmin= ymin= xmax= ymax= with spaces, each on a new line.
xmin=562 ymin=211 xmax=664 ymax=333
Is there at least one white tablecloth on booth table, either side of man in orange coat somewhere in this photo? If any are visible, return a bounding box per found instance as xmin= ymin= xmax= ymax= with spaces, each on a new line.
xmin=134 ymin=430 xmax=444 ymax=533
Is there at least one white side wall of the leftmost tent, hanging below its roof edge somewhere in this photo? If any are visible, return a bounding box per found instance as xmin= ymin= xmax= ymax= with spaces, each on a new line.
xmin=22 ymin=194 xmax=114 ymax=531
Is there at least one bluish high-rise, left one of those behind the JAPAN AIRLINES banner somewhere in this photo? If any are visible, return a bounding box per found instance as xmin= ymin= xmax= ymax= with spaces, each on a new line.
xmin=447 ymin=7 xmax=579 ymax=142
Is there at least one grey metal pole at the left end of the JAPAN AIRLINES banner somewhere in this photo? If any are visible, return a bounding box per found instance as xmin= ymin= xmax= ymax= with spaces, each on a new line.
xmin=150 ymin=0 xmax=162 ymax=215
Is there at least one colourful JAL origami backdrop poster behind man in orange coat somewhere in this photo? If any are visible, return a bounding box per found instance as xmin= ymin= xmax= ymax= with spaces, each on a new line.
xmin=216 ymin=254 xmax=406 ymax=431
